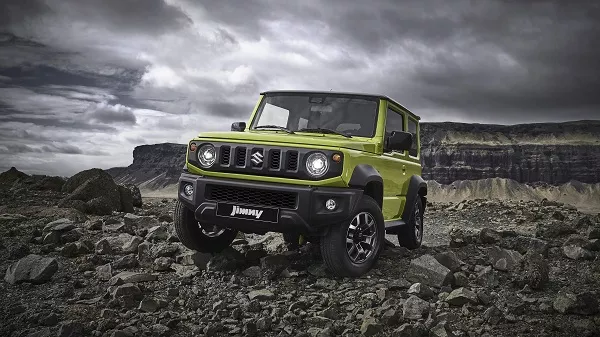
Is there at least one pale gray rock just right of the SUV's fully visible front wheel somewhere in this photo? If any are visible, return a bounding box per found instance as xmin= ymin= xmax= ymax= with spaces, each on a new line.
xmin=406 ymin=255 xmax=452 ymax=288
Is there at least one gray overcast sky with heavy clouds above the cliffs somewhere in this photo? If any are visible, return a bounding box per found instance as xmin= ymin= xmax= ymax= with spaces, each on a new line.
xmin=0 ymin=0 xmax=600 ymax=175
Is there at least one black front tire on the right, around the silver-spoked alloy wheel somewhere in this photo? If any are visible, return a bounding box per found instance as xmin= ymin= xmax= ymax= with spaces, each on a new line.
xmin=320 ymin=196 xmax=385 ymax=277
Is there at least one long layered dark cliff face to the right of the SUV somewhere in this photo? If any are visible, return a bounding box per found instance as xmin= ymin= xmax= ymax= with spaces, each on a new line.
xmin=421 ymin=121 xmax=600 ymax=184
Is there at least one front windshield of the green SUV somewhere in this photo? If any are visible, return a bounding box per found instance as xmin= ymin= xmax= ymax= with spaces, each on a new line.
xmin=251 ymin=93 xmax=379 ymax=137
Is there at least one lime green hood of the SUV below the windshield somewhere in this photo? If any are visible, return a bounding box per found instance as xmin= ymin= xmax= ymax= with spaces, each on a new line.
xmin=194 ymin=131 xmax=376 ymax=153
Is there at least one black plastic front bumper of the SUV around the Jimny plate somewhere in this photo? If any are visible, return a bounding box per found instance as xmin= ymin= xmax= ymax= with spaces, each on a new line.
xmin=178 ymin=173 xmax=363 ymax=236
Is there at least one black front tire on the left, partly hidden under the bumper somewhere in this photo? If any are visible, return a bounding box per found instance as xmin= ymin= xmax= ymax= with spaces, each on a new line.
xmin=173 ymin=200 xmax=238 ymax=253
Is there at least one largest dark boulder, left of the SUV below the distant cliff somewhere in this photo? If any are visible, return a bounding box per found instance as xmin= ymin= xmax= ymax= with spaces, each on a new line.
xmin=59 ymin=168 xmax=133 ymax=215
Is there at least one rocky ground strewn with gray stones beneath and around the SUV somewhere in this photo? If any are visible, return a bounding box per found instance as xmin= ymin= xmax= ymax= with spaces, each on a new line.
xmin=0 ymin=168 xmax=600 ymax=337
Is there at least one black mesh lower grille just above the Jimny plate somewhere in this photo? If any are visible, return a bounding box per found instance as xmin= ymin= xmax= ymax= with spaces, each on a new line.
xmin=204 ymin=184 xmax=297 ymax=209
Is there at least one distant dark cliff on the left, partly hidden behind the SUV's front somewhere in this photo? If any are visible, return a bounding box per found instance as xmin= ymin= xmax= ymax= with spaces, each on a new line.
xmin=107 ymin=143 xmax=186 ymax=190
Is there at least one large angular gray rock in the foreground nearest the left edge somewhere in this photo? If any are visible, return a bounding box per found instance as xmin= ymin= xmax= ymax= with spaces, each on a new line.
xmin=4 ymin=254 xmax=58 ymax=284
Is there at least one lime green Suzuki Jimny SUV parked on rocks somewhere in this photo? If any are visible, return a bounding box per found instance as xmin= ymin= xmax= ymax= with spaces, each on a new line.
xmin=174 ymin=91 xmax=427 ymax=277
